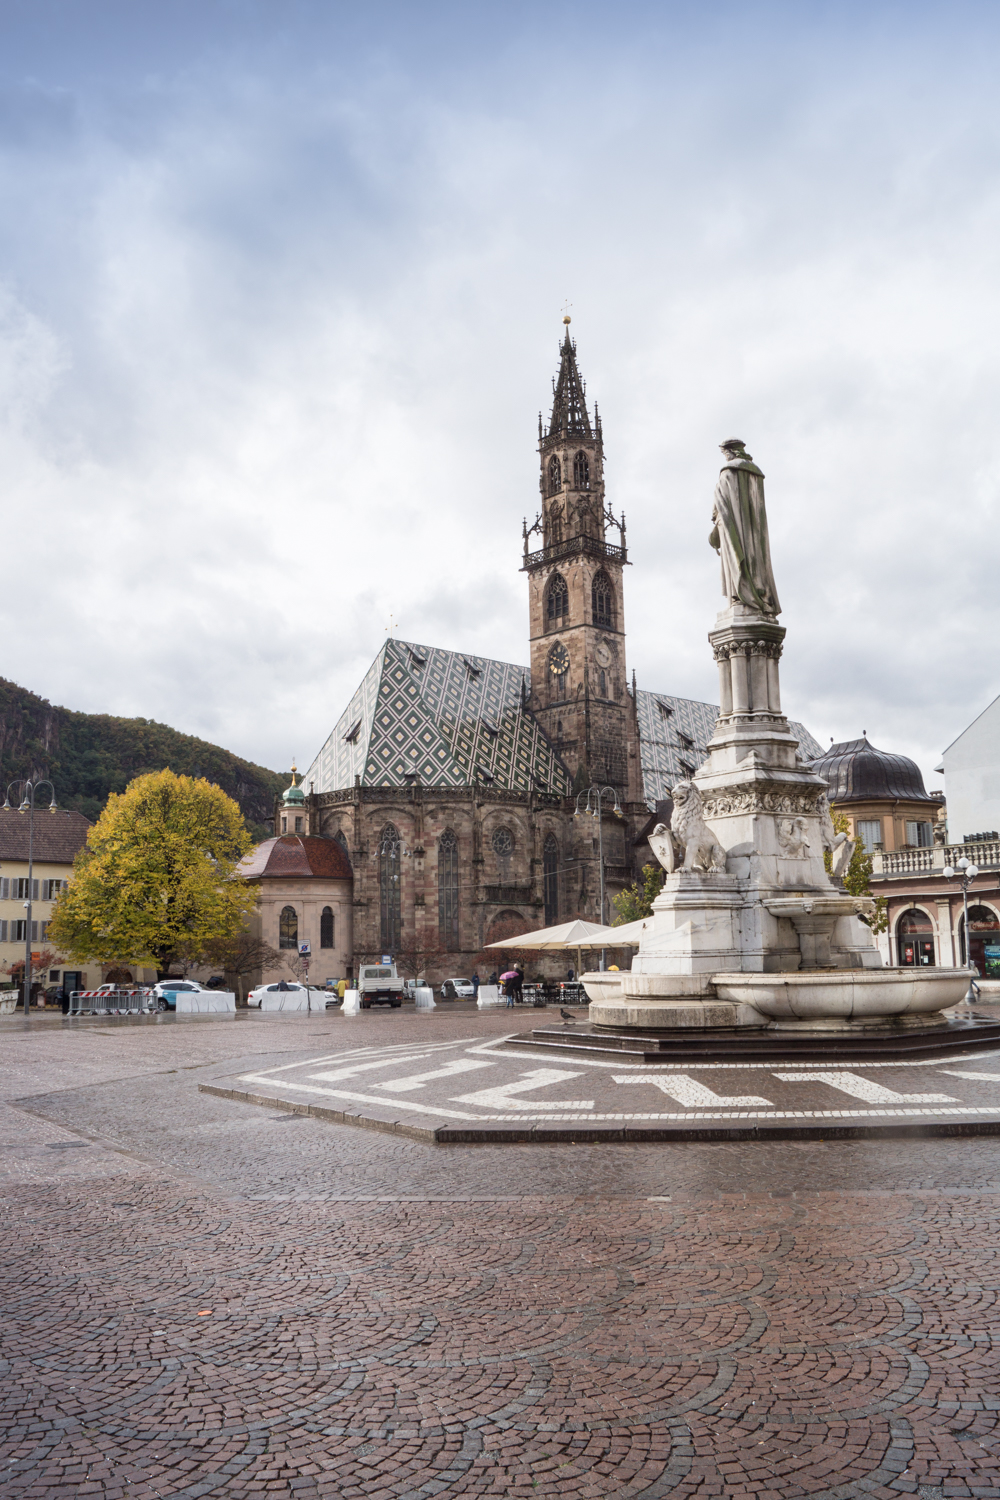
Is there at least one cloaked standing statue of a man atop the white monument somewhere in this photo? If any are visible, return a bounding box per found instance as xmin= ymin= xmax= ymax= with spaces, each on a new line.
xmin=708 ymin=438 xmax=781 ymax=615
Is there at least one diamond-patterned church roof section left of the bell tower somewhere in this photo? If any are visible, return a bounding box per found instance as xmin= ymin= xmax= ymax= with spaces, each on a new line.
xmin=303 ymin=641 xmax=571 ymax=797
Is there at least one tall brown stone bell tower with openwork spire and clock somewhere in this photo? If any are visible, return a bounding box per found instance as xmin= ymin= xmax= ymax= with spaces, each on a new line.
xmin=522 ymin=318 xmax=642 ymax=803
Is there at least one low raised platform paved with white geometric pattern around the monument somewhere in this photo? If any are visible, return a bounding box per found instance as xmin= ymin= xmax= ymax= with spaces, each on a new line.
xmin=211 ymin=1032 xmax=1000 ymax=1143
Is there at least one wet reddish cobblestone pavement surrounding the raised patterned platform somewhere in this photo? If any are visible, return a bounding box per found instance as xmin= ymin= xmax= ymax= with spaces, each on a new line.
xmin=0 ymin=1008 xmax=1000 ymax=1500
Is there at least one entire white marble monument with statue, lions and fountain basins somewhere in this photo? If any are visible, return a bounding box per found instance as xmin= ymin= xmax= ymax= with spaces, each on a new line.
xmin=583 ymin=438 xmax=969 ymax=1032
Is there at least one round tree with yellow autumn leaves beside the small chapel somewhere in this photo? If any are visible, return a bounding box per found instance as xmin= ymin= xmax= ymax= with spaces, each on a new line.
xmin=48 ymin=771 xmax=256 ymax=974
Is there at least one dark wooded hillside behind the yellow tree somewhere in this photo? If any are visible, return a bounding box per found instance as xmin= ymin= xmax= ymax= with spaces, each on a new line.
xmin=0 ymin=678 xmax=288 ymax=837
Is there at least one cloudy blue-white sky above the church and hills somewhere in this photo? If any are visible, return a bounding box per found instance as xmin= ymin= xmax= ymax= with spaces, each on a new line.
xmin=0 ymin=0 xmax=1000 ymax=785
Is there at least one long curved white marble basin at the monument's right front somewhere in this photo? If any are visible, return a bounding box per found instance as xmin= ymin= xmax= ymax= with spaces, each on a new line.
xmin=712 ymin=969 xmax=969 ymax=1022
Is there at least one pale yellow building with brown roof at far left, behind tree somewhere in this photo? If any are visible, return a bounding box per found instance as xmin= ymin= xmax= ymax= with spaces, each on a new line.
xmin=0 ymin=807 xmax=102 ymax=992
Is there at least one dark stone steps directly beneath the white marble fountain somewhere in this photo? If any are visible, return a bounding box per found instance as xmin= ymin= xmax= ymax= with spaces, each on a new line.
xmin=507 ymin=1016 xmax=1000 ymax=1062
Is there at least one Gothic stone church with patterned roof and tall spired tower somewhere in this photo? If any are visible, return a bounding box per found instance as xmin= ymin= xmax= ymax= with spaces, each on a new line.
xmin=262 ymin=318 xmax=820 ymax=984
